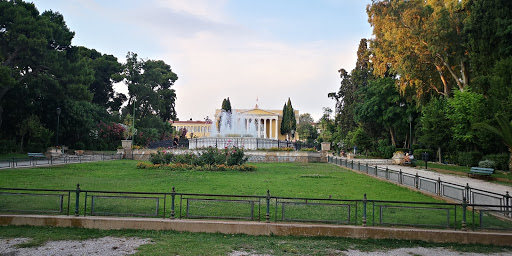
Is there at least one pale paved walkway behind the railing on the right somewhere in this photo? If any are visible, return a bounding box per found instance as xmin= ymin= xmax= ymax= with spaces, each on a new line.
xmin=342 ymin=157 xmax=512 ymax=195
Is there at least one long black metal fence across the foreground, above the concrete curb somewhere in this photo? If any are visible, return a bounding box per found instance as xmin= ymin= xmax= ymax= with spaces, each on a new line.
xmin=0 ymin=185 xmax=512 ymax=230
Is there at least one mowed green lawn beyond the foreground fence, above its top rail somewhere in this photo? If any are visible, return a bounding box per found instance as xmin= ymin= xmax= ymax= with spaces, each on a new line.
xmin=0 ymin=160 xmax=439 ymax=202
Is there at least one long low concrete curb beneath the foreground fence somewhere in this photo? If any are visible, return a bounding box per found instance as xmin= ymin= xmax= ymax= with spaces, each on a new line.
xmin=0 ymin=215 xmax=512 ymax=246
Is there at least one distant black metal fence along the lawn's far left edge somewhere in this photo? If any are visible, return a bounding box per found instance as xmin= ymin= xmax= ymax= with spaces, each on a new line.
xmin=0 ymin=154 xmax=123 ymax=169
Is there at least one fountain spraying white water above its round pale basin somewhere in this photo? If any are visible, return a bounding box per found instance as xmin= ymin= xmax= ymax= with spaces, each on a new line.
xmin=189 ymin=111 xmax=279 ymax=149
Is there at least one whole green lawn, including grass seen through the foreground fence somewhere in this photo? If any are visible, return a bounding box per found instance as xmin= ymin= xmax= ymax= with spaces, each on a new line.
xmin=0 ymin=160 xmax=511 ymax=233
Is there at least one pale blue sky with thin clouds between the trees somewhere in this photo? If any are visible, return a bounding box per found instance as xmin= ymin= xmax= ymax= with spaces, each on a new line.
xmin=33 ymin=0 xmax=371 ymax=120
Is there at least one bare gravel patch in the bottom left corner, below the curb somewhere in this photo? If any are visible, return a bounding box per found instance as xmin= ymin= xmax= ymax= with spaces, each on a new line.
xmin=0 ymin=237 xmax=151 ymax=256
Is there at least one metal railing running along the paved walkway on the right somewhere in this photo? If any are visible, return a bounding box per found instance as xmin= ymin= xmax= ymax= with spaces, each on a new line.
xmin=327 ymin=156 xmax=512 ymax=208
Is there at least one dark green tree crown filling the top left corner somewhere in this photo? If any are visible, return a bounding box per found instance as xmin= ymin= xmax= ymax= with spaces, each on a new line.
xmin=0 ymin=0 xmax=74 ymax=130
